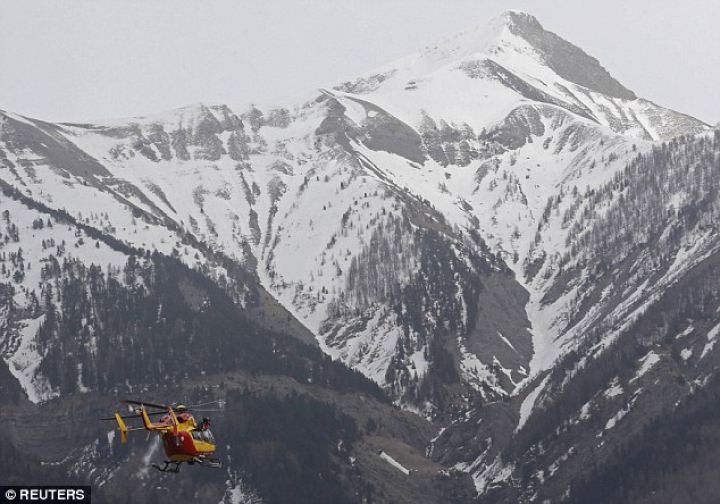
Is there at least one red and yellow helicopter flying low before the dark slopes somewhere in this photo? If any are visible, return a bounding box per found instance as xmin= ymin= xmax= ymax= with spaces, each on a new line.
xmin=102 ymin=399 xmax=221 ymax=473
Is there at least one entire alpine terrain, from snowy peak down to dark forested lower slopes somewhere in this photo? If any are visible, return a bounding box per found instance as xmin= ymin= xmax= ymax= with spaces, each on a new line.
xmin=0 ymin=11 xmax=720 ymax=504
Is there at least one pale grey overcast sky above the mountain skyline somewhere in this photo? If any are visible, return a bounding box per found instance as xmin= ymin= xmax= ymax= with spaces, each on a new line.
xmin=0 ymin=0 xmax=720 ymax=124
